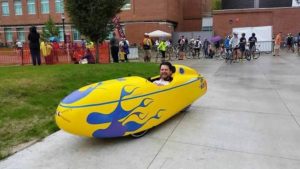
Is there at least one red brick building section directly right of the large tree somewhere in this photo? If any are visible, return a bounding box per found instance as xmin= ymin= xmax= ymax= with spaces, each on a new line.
xmin=119 ymin=0 xmax=211 ymax=43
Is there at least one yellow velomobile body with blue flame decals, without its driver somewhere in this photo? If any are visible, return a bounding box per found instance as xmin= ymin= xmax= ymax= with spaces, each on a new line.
xmin=55 ymin=65 xmax=207 ymax=138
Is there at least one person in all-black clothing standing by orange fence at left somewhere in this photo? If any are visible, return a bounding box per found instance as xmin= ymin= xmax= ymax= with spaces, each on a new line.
xmin=28 ymin=26 xmax=41 ymax=66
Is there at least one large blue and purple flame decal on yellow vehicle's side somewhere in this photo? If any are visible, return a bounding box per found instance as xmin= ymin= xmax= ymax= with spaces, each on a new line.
xmin=87 ymin=86 xmax=165 ymax=138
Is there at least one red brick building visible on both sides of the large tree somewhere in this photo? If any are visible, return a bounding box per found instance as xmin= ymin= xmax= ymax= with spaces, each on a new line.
xmin=0 ymin=0 xmax=211 ymax=44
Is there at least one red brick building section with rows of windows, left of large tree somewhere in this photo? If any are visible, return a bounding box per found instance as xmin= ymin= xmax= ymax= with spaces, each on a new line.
xmin=0 ymin=0 xmax=70 ymax=44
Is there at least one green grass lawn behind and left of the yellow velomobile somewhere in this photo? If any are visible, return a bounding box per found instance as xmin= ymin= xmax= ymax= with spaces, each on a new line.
xmin=0 ymin=63 xmax=159 ymax=159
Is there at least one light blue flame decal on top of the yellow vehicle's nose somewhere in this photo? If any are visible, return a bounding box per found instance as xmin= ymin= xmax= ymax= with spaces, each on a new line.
xmin=62 ymin=82 xmax=102 ymax=104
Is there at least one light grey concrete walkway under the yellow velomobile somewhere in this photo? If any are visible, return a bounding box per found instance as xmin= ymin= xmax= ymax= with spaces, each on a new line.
xmin=0 ymin=54 xmax=300 ymax=169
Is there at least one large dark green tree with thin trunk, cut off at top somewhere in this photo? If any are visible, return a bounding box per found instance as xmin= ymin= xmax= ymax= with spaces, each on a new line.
xmin=65 ymin=0 xmax=125 ymax=63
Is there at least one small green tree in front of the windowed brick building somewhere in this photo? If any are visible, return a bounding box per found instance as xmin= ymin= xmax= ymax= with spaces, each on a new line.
xmin=41 ymin=16 xmax=59 ymax=41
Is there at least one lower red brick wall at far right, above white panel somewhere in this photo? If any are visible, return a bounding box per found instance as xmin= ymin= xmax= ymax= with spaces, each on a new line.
xmin=213 ymin=7 xmax=300 ymax=36
